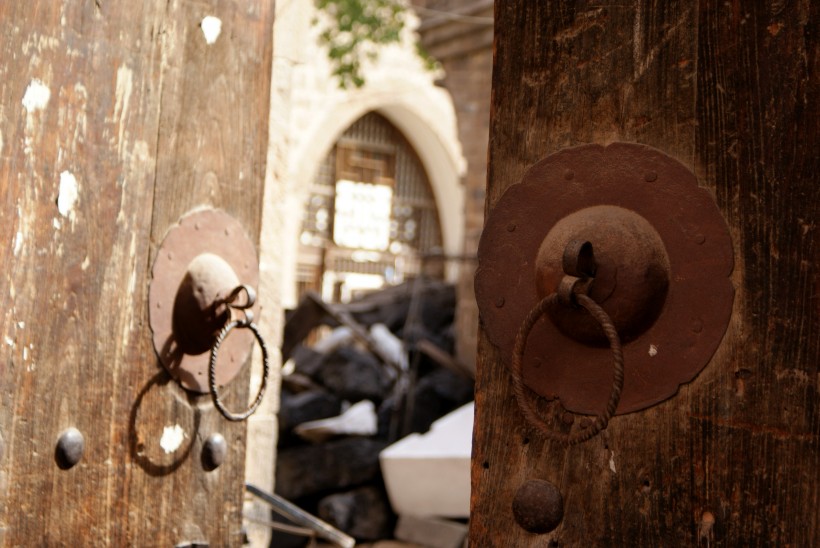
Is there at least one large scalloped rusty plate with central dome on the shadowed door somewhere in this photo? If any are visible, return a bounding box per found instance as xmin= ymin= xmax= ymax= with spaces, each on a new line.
xmin=475 ymin=143 xmax=734 ymax=414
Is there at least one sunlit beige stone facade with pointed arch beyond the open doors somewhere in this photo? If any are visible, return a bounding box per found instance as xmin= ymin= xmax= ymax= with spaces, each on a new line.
xmin=246 ymin=0 xmax=478 ymax=546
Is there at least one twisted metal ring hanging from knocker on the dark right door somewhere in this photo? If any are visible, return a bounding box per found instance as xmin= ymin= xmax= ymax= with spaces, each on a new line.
xmin=511 ymin=293 xmax=624 ymax=445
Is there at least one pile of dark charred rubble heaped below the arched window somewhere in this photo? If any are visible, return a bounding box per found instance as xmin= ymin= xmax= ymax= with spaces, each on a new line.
xmin=272 ymin=279 xmax=473 ymax=547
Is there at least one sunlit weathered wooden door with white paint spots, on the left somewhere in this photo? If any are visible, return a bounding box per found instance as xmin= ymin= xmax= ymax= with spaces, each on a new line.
xmin=0 ymin=0 xmax=273 ymax=546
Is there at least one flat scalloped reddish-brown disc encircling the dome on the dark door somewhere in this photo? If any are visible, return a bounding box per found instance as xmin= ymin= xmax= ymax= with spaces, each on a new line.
xmin=475 ymin=143 xmax=734 ymax=414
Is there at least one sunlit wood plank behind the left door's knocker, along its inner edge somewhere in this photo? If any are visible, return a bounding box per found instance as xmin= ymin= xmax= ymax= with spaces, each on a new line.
xmin=121 ymin=0 xmax=273 ymax=545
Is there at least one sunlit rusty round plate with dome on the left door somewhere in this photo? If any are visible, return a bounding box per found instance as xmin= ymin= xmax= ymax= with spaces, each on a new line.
xmin=148 ymin=209 xmax=261 ymax=399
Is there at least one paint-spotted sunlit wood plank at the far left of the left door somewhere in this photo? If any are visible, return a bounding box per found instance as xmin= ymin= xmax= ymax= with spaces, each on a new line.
xmin=0 ymin=2 xmax=168 ymax=545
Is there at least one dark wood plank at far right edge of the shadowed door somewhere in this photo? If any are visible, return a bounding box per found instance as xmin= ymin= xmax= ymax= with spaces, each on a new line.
xmin=688 ymin=0 xmax=820 ymax=546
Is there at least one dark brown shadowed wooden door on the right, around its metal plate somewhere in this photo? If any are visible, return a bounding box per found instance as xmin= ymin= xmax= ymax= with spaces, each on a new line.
xmin=470 ymin=0 xmax=820 ymax=547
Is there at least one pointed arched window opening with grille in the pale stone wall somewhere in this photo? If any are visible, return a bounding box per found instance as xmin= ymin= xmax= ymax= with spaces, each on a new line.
xmin=297 ymin=112 xmax=442 ymax=302
